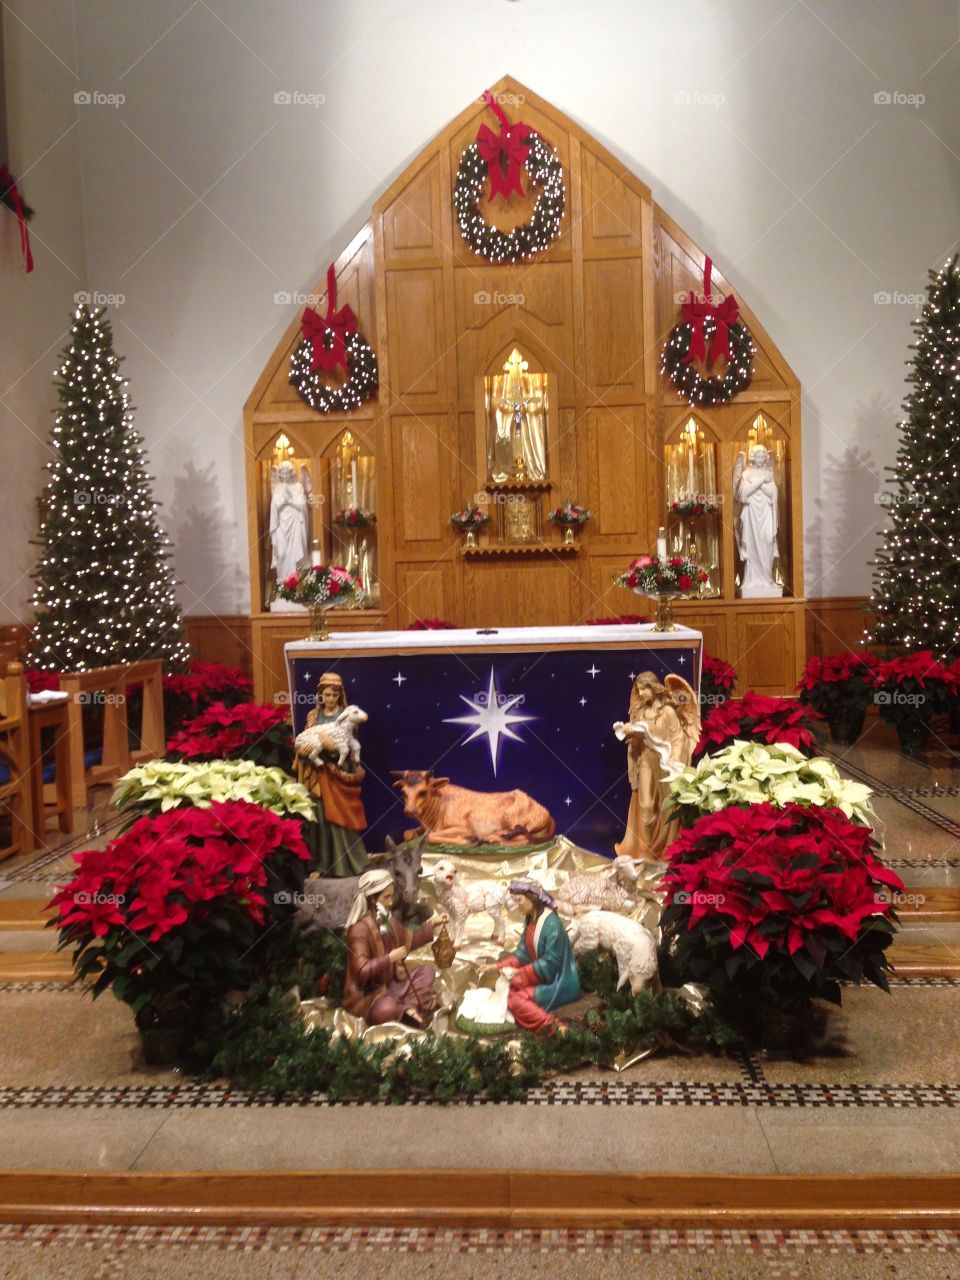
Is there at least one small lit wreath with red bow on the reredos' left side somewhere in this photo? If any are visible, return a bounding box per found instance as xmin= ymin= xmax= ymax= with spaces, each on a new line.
xmin=289 ymin=264 xmax=379 ymax=413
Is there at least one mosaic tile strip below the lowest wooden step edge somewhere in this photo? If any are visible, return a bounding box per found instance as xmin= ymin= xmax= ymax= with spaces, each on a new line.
xmin=0 ymin=1224 xmax=960 ymax=1254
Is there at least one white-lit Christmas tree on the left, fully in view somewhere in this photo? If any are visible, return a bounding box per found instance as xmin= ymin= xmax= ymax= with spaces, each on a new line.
xmin=29 ymin=305 xmax=188 ymax=671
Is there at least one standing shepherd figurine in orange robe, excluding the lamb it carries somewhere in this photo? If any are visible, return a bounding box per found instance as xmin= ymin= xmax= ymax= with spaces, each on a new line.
xmin=297 ymin=671 xmax=367 ymax=876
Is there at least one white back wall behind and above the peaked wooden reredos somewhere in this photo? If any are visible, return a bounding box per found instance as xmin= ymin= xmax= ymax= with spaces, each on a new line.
xmin=3 ymin=0 xmax=960 ymax=613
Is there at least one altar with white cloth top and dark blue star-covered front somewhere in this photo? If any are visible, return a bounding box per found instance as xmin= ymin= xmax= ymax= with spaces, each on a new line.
xmin=284 ymin=623 xmax=703 ymax=855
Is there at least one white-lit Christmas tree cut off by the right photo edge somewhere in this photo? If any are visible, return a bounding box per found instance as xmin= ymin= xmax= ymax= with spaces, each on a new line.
xmin=868 ymin=255 xmax=960 ymax=659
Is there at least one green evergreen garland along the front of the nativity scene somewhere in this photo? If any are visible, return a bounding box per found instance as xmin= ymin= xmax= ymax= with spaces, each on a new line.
xmin=193 ymin=925 xmax=740 ymax=1102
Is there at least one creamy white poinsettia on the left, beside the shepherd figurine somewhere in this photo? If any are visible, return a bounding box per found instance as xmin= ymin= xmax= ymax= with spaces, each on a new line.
xmin=113 ymin=760 xmax=315 ymax=820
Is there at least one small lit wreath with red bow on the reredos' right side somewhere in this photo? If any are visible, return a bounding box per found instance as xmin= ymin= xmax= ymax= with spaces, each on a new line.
xmin=660 ymin=257 xmax=756 ymax=406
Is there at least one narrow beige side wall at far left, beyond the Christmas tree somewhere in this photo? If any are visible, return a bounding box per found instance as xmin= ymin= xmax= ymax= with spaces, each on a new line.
xmin=0 ymin=0 xmax=86 ymax=623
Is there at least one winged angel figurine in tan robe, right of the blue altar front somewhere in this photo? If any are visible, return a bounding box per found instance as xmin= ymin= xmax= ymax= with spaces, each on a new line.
xmin=613 ymin=671 xmax=700 ymax=861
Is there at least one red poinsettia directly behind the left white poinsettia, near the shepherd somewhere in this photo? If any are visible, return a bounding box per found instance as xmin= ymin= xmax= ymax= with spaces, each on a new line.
xmin=166 ymin=703 xmax=293 ymax=773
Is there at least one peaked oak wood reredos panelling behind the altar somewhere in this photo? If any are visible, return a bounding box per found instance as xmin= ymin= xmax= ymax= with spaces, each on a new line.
xmin=244 ymin=77 xmax=804 ymax=698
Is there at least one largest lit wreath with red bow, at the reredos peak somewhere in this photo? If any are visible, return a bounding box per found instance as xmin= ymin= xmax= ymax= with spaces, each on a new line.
xmin=453 ymin=92 xmax=564 ymax=262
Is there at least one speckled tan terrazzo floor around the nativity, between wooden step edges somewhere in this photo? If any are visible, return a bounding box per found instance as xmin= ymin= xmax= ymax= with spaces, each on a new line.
xmin=0 ymin=724 xmax=960 ymax=1280
